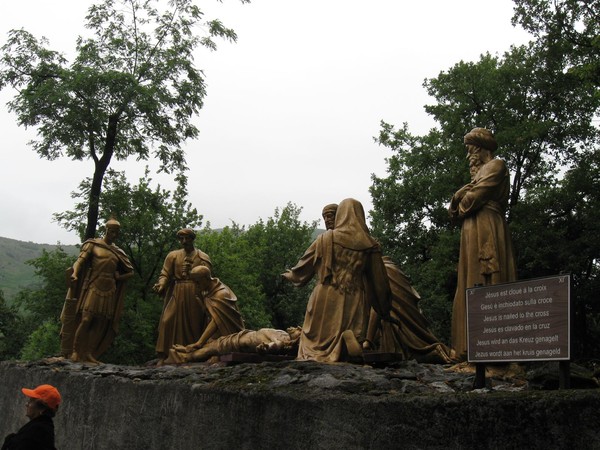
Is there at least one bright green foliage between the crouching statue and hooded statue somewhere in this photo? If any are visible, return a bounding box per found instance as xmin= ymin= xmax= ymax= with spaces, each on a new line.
xmin=198 ymin=203 xmax=317 ymax=329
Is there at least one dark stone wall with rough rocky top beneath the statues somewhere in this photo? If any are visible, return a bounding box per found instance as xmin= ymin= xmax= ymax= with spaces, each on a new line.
xmin=0 ymin=360 xmax=600 ymax=450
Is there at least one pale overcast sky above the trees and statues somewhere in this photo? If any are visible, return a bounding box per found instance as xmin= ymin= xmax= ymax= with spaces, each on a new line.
xmin=0 ymin=0 xmax=529 ymax=244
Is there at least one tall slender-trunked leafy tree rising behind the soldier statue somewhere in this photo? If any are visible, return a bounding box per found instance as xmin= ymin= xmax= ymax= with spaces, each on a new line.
xmin=0 ymin=0 xmax=246 ymax=238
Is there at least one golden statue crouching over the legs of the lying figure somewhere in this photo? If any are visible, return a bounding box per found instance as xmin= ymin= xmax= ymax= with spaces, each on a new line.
xmin=177 ymin=266 xmax=244 ymax=351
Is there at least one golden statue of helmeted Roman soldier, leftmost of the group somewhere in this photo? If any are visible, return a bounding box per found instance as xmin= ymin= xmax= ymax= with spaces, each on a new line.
xmin=61 ymin=219 xmax=134 ymax=364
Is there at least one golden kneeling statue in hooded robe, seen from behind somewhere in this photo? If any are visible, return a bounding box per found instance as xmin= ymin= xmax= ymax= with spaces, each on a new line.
xmin=283 ymin=198 xmax=391 ymax=362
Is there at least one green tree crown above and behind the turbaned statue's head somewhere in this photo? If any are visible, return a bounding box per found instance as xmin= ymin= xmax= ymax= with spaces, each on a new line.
xmin=425 ymin=44 xmax=598 ymax=207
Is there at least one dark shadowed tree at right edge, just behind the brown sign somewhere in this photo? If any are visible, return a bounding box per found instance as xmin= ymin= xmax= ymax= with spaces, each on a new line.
xmin=513 ymin=152 xmax=600 ymax=355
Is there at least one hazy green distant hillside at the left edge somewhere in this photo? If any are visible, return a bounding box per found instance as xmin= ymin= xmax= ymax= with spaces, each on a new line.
xmin=0 ymin=237 xmax=79 ymax=303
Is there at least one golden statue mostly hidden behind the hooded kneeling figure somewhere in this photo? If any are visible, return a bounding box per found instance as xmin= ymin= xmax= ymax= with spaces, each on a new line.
xmin=322 ymin=203 xmax=454 ymax=364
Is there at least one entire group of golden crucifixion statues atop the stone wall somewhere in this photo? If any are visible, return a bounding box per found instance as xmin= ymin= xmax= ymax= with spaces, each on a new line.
xmin=61 ymin=128 xmax=516 ymax=365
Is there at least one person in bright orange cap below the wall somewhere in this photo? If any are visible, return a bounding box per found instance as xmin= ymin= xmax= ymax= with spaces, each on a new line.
xmin=2 ymin=384 xmax=62 ymax=450
